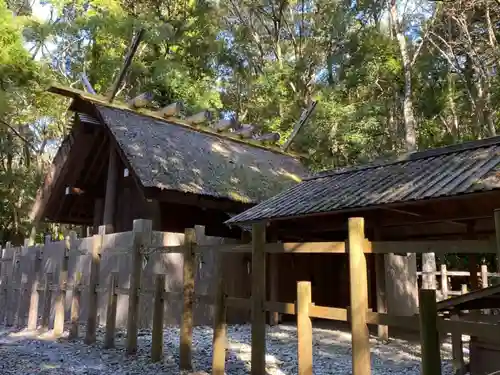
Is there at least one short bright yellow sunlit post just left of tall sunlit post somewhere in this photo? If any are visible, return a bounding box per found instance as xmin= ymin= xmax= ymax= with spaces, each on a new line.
xmin=297 ymin=281 xmax=313 ymax=375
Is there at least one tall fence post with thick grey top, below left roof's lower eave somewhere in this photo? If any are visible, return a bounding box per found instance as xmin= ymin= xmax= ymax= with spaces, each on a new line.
xmin=127 ymin=219 xmax=152 ymax=355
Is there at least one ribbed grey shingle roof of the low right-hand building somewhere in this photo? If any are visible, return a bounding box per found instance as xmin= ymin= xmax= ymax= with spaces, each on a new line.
xmin=226 ymin=137 xmax=500 ymax=224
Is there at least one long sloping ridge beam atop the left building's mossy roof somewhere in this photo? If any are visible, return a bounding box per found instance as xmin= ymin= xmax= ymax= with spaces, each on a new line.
xmin=48 ymin=84 xmax=303 ymax=159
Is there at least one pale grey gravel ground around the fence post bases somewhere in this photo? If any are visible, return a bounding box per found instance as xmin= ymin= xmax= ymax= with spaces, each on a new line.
xmin=0 ymin=325 xmax=460 ymax=375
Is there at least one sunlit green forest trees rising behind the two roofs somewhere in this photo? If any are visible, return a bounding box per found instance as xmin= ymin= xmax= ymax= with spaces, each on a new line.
xmin=0 ymin=0 xmax=500 ymax=242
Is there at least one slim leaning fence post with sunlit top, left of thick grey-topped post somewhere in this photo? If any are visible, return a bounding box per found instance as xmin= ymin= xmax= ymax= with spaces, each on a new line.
xmin=84 ymin=225 xmax=106 ymax=345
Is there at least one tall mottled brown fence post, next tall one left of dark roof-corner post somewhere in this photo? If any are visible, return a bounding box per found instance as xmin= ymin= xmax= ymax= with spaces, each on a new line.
xmin=180 ymin=228 xmax=196 ymax=371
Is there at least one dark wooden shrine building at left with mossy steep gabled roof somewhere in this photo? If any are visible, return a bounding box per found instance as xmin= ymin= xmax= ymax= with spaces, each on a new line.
xmin=32 ymin=86 xmax=306 ymax=238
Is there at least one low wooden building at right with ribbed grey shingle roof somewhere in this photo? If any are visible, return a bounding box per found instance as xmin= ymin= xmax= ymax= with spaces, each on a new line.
xmin=226 ymin=137 xmax=500 ymax=326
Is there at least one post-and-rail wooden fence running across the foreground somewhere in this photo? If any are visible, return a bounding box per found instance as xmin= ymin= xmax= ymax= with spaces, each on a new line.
xmin=0 ymin=218 xmax=500 ymax=375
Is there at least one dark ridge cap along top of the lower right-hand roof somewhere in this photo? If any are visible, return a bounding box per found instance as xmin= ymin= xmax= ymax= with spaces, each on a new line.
xmin=303 ymin=136 xmax=500 ymax=181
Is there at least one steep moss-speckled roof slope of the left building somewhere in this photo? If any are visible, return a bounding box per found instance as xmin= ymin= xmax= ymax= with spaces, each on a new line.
xmin=96 ymin=105 xmax=306 ymax=203
